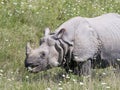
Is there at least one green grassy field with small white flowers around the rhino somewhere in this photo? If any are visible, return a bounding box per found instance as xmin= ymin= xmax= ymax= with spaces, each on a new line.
xmin=0 ymin=0 xmax=120 ymax=90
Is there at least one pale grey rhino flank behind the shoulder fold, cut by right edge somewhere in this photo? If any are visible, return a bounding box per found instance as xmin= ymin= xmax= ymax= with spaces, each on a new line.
xmin=87 ymin=13 xmax=120 ymax=59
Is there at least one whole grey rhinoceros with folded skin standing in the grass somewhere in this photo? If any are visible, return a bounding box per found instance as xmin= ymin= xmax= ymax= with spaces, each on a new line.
xmin=25 ymin=13 xmax=120 ymax=75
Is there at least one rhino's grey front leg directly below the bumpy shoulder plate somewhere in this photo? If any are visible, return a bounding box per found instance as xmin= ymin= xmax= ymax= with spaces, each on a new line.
xmin=78 ymin=59 xmax=91 ymax=76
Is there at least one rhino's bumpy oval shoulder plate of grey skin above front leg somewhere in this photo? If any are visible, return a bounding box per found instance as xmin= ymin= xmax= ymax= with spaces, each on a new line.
xmin=73 ymin=22 xmax=99 ymax=62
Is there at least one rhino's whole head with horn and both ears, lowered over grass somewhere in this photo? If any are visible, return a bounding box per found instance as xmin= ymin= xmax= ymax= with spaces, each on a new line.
xmin=25 ymin=28 xmax=64 ymax=72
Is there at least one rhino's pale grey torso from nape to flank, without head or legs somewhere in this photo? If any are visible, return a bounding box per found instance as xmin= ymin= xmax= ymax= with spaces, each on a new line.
xmin=55 ymin=13 xmax=120 ymax=61
